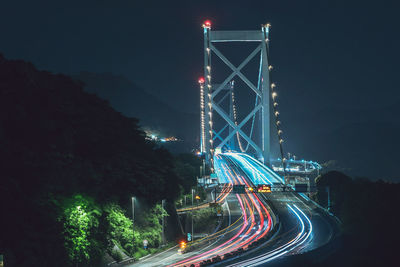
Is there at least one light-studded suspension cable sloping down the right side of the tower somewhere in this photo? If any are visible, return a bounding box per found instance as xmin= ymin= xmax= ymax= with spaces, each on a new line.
xmin=263 ymin=23 xmax=287 ymax=183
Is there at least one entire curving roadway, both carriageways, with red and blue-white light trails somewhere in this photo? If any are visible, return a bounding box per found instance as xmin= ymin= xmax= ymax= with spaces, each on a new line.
xmin=129 ymin=153 xmax=336 ymax=266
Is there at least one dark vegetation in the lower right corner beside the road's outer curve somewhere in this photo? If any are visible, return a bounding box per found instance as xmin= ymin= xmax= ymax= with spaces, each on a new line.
xmin=306 ymin=171 xmax=400 ymax=266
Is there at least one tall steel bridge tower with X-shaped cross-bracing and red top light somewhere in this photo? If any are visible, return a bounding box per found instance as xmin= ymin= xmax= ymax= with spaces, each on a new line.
xmin=199 ymin=21 xmax=273 ymax=168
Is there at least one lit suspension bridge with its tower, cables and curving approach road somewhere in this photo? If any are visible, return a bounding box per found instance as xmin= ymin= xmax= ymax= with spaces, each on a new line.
xmin=128 ymin=20 xmax=337 ymax=266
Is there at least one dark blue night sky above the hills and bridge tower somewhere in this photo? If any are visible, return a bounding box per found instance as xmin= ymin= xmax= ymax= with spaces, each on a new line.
xmin=0 ymin=0 xmax=400 ymax=179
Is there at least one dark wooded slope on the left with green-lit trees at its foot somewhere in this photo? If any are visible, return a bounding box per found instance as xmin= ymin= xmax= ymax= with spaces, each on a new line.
xmin=0 ymin=55 xmax=199 ymax=266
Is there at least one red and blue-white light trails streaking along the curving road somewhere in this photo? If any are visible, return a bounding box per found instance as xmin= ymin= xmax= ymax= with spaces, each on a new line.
xmin=170 ymin=153 xmax=313 ymax=266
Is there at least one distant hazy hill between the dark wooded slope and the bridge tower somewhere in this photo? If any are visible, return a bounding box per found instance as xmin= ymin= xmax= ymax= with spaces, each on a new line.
xmin=73 ymin=72 xmax=199 ymax=147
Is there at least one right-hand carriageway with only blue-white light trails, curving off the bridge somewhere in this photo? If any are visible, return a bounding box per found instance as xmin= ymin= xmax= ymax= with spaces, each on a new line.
xmin=213 ymin=153 xmax=338 ymax=266
